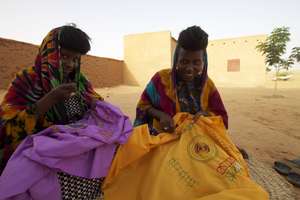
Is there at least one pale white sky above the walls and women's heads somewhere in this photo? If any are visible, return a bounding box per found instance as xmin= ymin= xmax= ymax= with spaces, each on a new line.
xmin=0 ymin=0 xmax=300 ymax=63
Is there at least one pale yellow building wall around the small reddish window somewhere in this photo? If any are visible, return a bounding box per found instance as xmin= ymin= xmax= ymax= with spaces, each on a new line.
xmin=207 ymin=35 xmax=266 ymax=87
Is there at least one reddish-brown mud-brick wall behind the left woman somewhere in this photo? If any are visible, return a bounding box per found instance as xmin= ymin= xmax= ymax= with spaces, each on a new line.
xmin=0 ymin=38 xmax=124 ymax=89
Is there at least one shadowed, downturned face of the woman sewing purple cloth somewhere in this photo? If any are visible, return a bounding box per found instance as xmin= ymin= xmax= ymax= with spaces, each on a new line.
xmin=60 ymin=48 xmax=81 ymax=80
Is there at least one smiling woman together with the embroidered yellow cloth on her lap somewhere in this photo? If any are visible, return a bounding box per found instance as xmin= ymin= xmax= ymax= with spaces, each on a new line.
xmin=103 ymin=26 xmax=268 ymax=200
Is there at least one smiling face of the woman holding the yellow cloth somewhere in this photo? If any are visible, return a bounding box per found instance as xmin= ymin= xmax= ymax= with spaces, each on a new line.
xmin=176 ymin=48 xmax=204 ymax=82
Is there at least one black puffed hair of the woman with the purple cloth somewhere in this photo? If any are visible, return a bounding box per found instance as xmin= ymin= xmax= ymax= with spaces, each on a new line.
xmin=58 ymin=25 xmax=91 ymax=54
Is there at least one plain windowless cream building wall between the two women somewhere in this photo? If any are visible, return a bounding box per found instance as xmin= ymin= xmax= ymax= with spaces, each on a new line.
xmin=124 ymin=31 xmax=172 ymax=87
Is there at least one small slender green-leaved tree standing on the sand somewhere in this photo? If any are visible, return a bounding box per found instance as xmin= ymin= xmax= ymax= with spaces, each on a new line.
xmin=256 ymin=27 xmax=300 ymax=92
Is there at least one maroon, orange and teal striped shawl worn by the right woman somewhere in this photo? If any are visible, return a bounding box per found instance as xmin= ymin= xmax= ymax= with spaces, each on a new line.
xmin=134 ymin=59 xmax=228 ymax=134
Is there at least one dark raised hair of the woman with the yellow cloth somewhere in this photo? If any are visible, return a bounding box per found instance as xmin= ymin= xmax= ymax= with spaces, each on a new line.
xmin=177 ymin=26 xmax=208 ymax=51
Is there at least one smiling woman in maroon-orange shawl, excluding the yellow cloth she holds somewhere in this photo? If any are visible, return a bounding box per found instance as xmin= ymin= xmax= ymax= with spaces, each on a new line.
xmin=134 ymin=26 xmax=228 ymax=134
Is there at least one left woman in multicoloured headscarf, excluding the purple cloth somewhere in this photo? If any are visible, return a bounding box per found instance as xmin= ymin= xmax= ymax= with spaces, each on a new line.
xmin=0 ymin=26 xmax=102 ymax=171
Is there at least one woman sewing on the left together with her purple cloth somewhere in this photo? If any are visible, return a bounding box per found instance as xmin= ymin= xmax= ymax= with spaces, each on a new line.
xmin=0 ymin=26 xmax=132 ymax=199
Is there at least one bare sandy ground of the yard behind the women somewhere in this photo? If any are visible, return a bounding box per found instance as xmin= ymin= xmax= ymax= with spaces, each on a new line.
xmin=0 ymin=79 xmax=300 ymax=197
